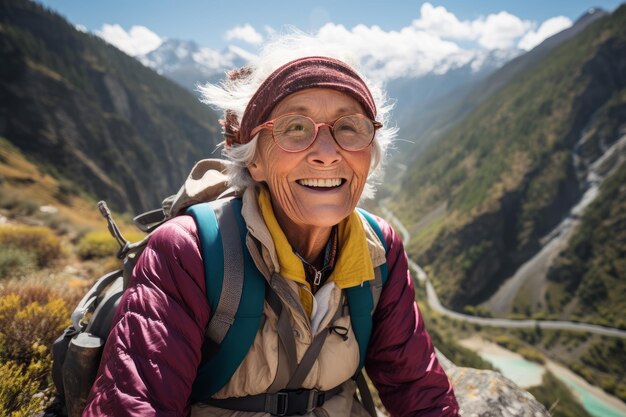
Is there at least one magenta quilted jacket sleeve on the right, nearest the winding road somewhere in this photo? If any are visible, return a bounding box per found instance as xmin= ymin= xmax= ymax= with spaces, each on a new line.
xmin=365 ymin=219 xmax=459 ymax=417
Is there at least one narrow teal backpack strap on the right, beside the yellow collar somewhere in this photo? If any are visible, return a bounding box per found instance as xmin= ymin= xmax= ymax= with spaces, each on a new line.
xmin=345 ymin=208 xmax=388 ymax=375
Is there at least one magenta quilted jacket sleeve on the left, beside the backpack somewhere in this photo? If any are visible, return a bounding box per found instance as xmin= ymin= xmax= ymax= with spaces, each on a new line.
xmin=83 ymin=216 xmax=209 ymax=417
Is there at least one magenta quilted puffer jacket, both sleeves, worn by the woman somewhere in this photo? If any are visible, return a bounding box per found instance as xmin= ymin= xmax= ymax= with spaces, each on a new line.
xmin=83 ymin=211 xmax=458 ymax=417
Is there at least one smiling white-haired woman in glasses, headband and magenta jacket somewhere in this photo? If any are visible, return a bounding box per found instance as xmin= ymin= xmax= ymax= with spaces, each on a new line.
xmin=83 ymin=36 xmax=458 ymax=417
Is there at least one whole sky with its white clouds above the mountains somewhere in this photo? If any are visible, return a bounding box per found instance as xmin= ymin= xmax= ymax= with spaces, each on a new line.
xmin=37 ymin=0 xmax=619 ymax=82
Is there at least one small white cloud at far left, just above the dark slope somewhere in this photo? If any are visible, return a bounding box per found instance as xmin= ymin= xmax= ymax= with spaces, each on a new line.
xmin=96 ymin=24 xmax=163 ymax=56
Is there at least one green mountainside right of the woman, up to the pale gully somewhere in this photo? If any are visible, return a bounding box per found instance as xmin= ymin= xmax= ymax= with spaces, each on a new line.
xmin=389 ymin=6 xmax=626 ymax=318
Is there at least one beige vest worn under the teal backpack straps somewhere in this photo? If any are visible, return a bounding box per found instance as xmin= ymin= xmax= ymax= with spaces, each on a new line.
xmin=191 ymin=189 xmax=385 ymax=417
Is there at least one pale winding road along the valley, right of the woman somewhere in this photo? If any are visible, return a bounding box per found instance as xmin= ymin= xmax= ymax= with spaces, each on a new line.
xmin=379 ymin=202 xmax=626 ymax=339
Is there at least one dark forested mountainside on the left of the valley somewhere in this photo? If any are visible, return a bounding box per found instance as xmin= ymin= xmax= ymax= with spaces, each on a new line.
xmin=0 ymin=0 xmax=221 ymax=211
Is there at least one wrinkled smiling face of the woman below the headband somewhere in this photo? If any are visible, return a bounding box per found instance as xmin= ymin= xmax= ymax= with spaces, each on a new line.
xmin=248 ymin=88 xmax=372 ymax=235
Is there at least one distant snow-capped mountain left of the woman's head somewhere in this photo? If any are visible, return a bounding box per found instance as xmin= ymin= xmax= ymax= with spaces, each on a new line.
xmin=136 ymin=39 xmax=251 ymax=91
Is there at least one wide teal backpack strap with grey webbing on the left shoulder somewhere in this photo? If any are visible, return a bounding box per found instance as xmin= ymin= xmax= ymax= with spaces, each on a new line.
xmin=187 ymin=199 xmax=265 ymax=403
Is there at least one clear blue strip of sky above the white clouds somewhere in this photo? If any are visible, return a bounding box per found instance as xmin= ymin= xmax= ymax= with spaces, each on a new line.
xmin=38 ymin=0 xmax=620 ymax=49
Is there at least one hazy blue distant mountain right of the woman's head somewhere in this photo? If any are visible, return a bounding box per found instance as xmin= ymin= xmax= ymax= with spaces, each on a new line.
xmin=397 ymin=8 xmax=607 ymax=164
